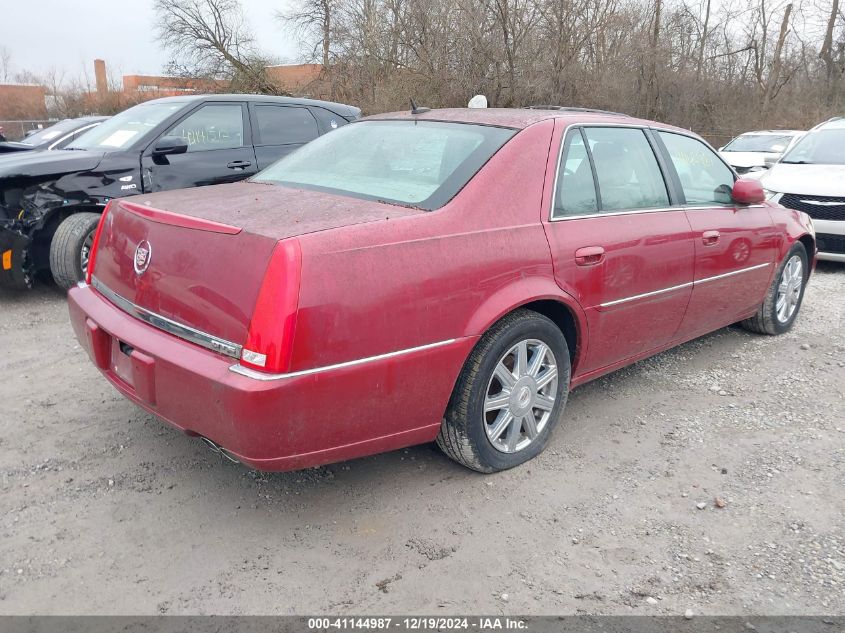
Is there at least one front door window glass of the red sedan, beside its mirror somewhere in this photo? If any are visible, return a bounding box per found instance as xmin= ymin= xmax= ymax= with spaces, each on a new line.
xmin=658 ymin=132 xmax=734 ymax=205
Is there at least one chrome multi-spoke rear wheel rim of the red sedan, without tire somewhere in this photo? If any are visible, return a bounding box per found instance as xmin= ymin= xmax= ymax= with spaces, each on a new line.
xmin=483 ymin=339 xmax=558 ymax=453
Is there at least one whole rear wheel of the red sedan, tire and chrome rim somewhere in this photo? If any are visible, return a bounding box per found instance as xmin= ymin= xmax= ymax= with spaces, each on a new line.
xmin=437 ymin=309 xmax=570 ymax=473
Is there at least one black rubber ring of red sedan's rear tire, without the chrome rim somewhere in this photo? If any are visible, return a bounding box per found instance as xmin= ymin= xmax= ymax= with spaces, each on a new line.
xmin=458 ymin=314 xmax=570 ymax=470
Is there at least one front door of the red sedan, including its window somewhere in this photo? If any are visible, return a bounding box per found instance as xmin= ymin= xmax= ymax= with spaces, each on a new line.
xmin=655 ymin=130 xmax=780 ymax=338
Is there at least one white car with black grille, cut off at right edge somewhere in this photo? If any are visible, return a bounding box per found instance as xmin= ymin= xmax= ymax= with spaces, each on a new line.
xmin=759 ymin=117 xmax=845 ymax=262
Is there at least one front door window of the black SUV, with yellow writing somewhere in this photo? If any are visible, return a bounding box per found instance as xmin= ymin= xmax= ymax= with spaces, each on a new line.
xmin=165 ymin=104 xmax=244 ymax=152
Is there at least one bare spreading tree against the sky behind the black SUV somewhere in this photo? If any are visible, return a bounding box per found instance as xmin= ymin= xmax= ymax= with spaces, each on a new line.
xmin=154 ymin=0 xmax=281 ymax=94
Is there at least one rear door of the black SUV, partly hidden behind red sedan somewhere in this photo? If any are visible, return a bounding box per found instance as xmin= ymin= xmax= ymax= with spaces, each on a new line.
xmin=250 ymin=103 xmax=319 ymax=169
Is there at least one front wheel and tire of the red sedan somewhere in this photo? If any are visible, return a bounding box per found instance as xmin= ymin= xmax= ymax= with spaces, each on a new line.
xmin=740 ymin=242 xmax=810 ymax=336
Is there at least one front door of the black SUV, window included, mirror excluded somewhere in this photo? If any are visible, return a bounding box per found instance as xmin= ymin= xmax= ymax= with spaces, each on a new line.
xmin=141 ymin=102 xmax=258 ymax=191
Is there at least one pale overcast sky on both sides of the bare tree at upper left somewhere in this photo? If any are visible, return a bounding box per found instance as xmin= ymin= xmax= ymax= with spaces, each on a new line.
xmin=0 ymin=0 xmax=299 ymax=81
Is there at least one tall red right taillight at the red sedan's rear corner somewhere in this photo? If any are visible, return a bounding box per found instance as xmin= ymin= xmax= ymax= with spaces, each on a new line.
xmin=241 ymin=239 xmax=302 ymax=373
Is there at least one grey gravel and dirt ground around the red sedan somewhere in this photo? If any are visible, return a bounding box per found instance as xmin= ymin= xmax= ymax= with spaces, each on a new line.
xmin=0 ymin=265 xmax=845 ymax=615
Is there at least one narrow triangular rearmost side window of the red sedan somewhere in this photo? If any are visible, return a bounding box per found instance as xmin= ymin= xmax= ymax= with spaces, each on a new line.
xmin=552 ymin=129 xmax=598 ymax=217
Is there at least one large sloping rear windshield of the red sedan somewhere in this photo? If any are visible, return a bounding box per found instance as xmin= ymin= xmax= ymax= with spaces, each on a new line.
xmin=253 ymin=121 xmax=516 ymax=210
